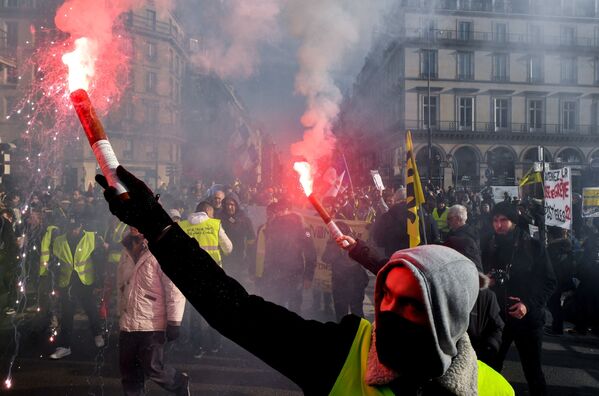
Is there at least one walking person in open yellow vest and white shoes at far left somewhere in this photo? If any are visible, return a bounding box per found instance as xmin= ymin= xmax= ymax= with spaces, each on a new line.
xmin=50 ymin=217 xmax=107 ymax=359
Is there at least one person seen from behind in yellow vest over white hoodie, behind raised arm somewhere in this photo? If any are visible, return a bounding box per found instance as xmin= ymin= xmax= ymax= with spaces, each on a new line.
xmin=179 ymin=201 xmax=233 ymax=359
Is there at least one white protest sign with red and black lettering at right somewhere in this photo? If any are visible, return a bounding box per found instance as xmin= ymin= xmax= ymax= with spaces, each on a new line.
xmin=544 ymin=166 xmax=572 ymax=229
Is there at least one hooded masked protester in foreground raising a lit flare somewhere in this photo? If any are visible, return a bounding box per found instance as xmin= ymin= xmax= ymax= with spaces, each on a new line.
xmin=96 ymin=167 xmax=514 ymax=396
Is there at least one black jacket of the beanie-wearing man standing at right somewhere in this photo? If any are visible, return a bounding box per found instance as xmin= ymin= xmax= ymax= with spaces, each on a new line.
xmin=482 ymin=227 xmax=557 ymax=326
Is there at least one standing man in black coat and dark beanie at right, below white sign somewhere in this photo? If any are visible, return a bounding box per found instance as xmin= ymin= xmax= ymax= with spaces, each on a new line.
xmin=482 ymin=202 xmax=556 ymax=395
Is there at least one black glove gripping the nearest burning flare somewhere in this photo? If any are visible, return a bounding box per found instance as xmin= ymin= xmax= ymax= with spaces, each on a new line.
xmin=96 ymin=166 xmax=173 ymax=241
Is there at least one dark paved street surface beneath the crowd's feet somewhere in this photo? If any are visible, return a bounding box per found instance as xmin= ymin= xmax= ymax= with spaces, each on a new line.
xmin=0 ymin=288 xmax=599 ymax=396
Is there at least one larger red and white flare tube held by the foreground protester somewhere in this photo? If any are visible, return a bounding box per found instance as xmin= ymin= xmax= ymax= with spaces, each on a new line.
xmin=70 ymin=89 xmax=129 ymax=199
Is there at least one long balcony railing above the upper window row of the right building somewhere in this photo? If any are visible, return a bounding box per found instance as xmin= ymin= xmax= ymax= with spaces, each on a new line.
xmin=405 ymin=28 xmax=599 ymax=49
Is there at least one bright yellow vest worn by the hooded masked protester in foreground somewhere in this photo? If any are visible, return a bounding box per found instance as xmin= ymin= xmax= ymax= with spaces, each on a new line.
xmin=329 ymin=319 xmax=514 ymax=396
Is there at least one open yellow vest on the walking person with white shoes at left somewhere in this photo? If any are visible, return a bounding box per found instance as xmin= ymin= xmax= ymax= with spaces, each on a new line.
xmin=52 ymin=231 xmax=96 ymax=287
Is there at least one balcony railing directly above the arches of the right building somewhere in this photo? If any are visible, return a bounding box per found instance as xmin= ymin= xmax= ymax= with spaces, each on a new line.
xmin=405 ymin=120 xmax=599 ymax=137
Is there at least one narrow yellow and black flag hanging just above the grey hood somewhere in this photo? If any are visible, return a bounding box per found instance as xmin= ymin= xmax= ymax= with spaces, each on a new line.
xmin=406 ymin=131 xmax=424 ymax=247
